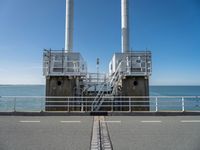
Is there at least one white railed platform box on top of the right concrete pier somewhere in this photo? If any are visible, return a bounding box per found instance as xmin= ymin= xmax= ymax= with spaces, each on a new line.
xmin=109 ymin=51 xmax=152 ymax=76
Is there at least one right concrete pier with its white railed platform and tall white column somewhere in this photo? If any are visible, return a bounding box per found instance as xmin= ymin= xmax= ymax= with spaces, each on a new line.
xmin=109 ymin=0 xmax=152 ymax=111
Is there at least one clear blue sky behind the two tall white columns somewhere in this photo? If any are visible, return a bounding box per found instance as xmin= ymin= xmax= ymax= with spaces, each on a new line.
xmin=0 ymin=0 xmax=200 ymax=85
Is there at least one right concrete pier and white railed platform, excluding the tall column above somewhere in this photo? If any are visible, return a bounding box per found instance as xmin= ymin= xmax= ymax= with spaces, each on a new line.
xmin=109 ymin=51 xmax=152 ymax=111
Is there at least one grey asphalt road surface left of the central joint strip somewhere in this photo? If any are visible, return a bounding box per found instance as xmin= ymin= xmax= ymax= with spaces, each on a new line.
xmin=0 ymin=116 xmax=93 ymax=150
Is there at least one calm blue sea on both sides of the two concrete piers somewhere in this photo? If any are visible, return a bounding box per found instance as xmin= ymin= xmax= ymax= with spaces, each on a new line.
xmin=0 ymin=85 xmax=200 ymax=111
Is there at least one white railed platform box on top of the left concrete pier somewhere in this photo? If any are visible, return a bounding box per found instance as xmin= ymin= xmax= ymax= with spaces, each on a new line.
xmin=43 ymin=49 xmax=87 ymax=76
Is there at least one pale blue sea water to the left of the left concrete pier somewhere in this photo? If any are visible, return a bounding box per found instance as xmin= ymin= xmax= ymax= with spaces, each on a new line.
xmin=0 ymin=85 xmax=45 ymax=112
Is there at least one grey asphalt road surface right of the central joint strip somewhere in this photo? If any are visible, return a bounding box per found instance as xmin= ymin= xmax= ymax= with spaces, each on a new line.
xmin=106 ymin=116 xmax=200 ymax=150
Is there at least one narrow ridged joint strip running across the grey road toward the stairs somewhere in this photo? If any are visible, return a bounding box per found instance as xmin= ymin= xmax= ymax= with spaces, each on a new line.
xmin=90 ymin=116 xmax=113 ymax=150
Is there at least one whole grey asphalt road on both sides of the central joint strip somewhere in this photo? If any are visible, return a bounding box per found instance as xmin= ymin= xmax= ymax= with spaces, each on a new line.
xmin=0 ymin=116 xmax=200 ymax=150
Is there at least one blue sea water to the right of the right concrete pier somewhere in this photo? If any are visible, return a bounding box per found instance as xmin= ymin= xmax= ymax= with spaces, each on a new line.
xmin=150 ymin=86 xmax=200 ymax=111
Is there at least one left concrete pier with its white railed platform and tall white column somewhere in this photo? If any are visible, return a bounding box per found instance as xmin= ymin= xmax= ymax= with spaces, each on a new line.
xmin=43 ymin=0 xmax=87 ymax=111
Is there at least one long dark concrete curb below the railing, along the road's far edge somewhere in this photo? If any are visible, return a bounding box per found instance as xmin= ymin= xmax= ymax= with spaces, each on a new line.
xmin=0 ymin=112 xmax=200 ymax=116
